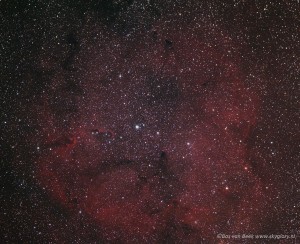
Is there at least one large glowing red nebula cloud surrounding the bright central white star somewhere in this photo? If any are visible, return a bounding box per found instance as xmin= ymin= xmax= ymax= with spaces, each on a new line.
xmin=31 ymin=16 xmax=274 ymax=243
